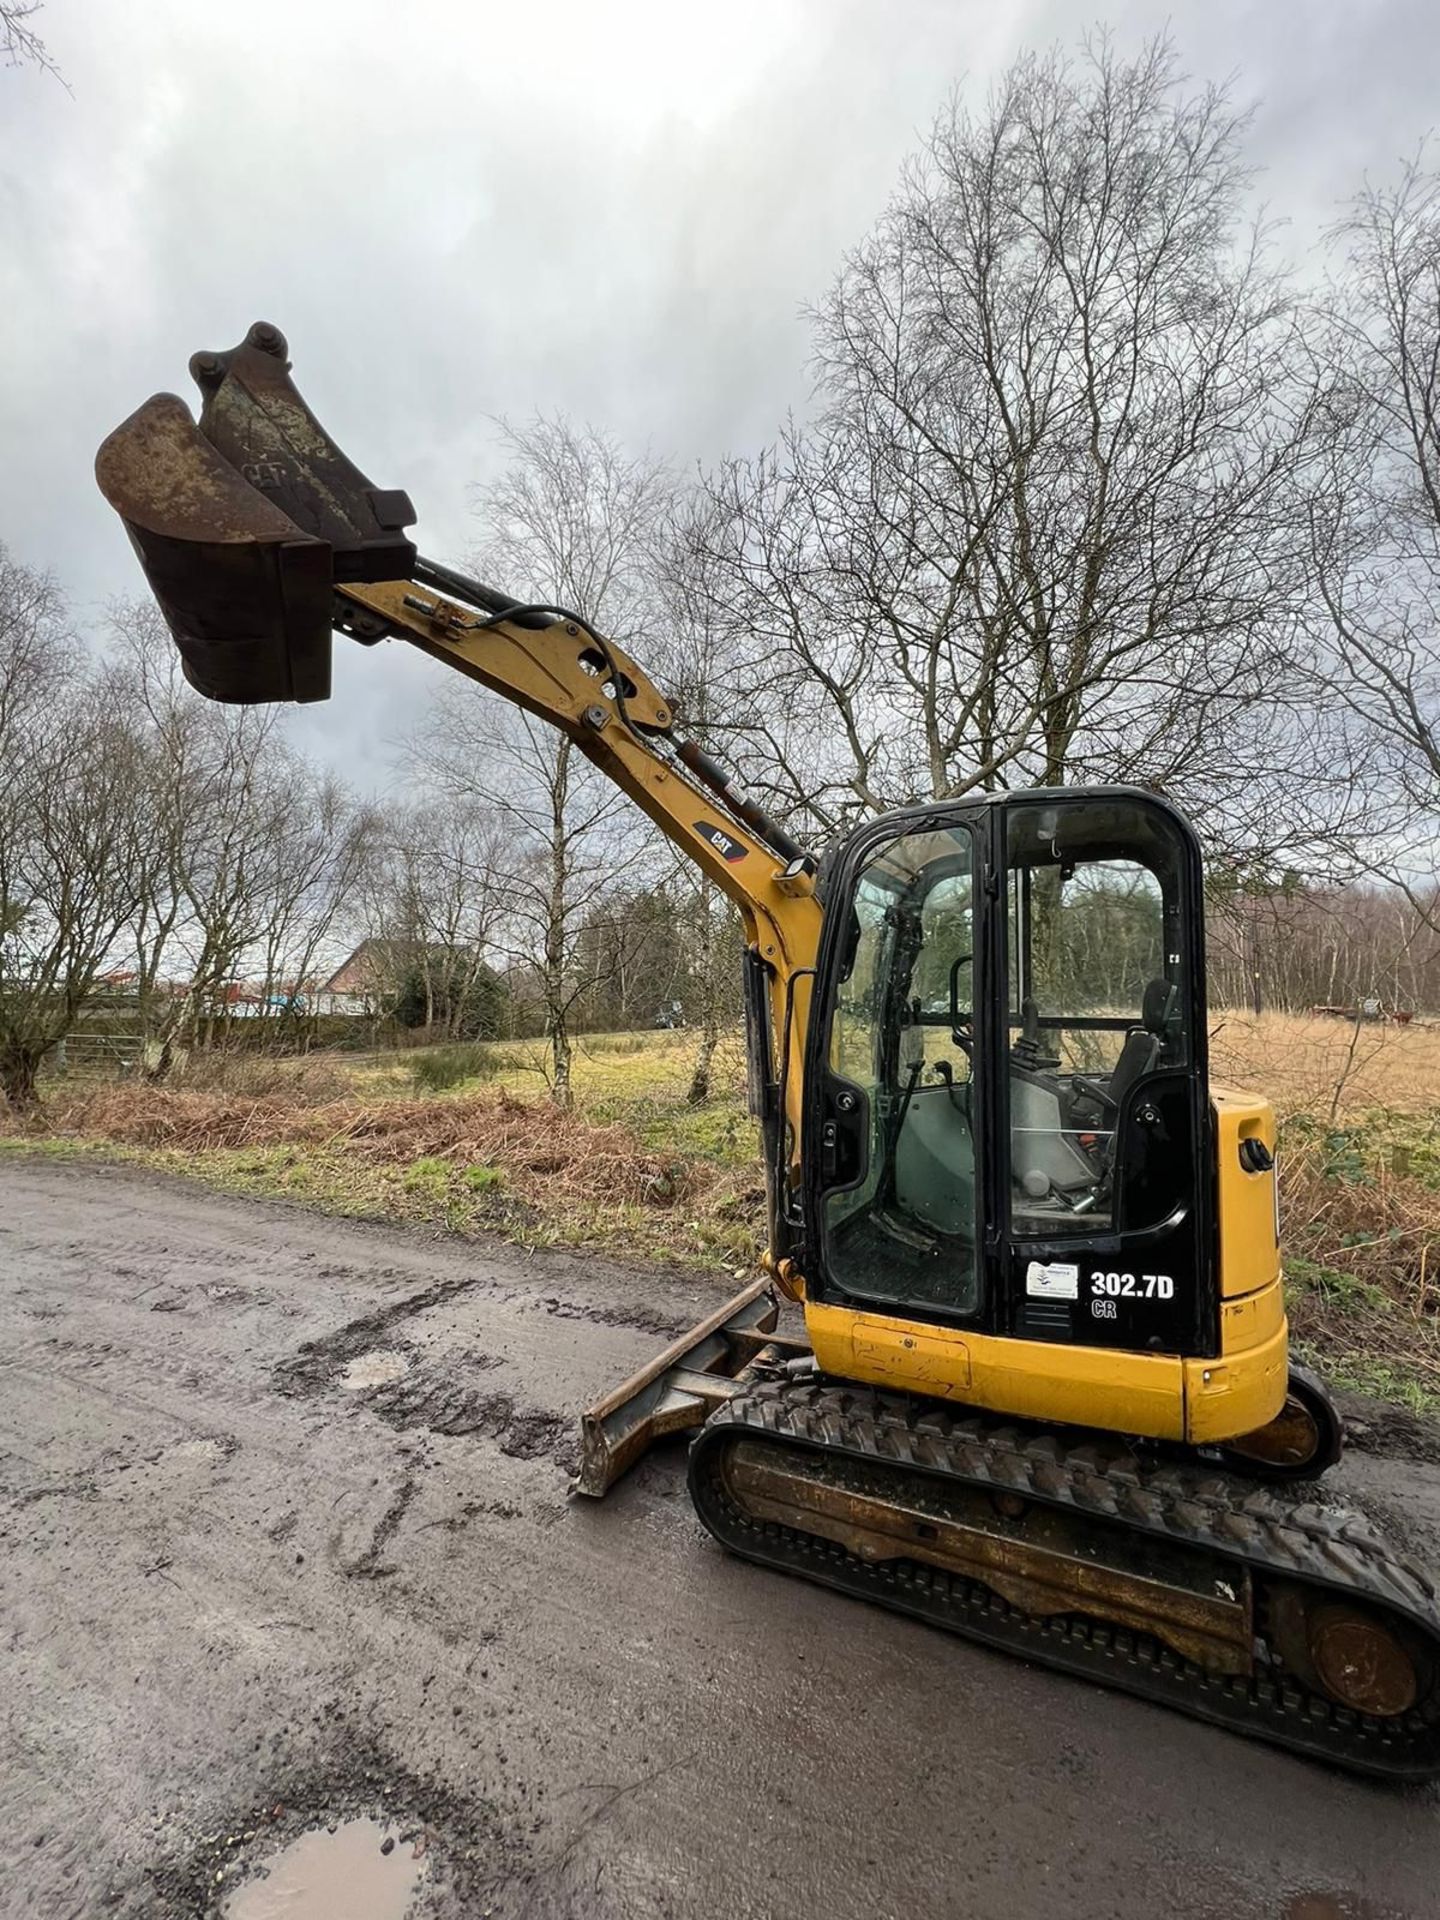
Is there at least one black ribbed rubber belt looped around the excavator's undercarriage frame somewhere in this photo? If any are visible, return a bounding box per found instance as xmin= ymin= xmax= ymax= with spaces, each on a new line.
xmin=689 ymin=1382 xmax=1440 ymax=1780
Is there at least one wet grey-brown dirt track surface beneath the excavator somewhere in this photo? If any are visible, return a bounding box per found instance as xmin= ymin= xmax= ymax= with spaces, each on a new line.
xmin=0 ymin=1160 xmax=1440 ymax=1920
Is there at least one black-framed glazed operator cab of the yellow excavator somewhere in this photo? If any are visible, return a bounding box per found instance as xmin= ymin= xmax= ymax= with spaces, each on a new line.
xmin=806 ymin=787 xmax=1210 ymax=1350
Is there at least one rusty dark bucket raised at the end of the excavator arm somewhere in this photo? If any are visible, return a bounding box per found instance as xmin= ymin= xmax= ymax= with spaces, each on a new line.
xmin=96 ymin=321 xmax=415 ymax=705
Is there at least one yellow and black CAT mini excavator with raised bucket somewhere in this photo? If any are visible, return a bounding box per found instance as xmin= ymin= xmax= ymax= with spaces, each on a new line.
xmin=96 ymin=324 xmax=1440 ymax=1778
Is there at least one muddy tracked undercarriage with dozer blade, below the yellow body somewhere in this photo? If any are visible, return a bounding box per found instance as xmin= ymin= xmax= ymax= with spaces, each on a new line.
xmin=580 ymin=1286 xmax=1440 ymax=1780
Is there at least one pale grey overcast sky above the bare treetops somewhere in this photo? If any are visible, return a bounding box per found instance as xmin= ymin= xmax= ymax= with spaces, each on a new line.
xmin=0 ymin=0 xmax=1440 ymax=785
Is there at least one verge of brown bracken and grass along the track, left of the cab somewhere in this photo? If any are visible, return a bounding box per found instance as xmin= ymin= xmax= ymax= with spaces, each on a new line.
xmin=0 ymin=1079 xmax=764 ymax=1273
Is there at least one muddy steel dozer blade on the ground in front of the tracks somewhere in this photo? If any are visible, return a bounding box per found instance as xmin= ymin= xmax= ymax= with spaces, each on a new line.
xmin=570 ymin=1281 xmax=810 ymax=1500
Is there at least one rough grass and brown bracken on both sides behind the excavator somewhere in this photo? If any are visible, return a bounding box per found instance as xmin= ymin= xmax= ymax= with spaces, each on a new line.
xmin=11 ymin=1016 xmax=1440 ymax=1415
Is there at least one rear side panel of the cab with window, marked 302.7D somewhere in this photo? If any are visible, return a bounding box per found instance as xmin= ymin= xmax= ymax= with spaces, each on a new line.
xmin=995 ymin=789 xmax=1219 ymax=1354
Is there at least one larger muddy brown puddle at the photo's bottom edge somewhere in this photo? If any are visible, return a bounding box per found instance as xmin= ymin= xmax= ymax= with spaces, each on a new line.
xmin=221 ymin=1820 xmax=424 ymax=1920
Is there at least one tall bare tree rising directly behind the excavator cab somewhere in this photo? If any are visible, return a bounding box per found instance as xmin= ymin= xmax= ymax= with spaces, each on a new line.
xmin=699 ymin=40 xmax=1302 ymax=829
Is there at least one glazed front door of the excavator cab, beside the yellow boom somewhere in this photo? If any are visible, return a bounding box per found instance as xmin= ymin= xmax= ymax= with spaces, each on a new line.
xmin=804 ymin=808 xmax=993 ymax=1323
